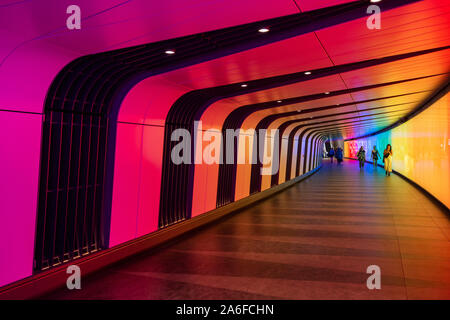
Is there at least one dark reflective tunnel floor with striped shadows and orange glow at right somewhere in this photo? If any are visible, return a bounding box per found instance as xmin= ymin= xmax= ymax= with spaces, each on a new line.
xmin=45 ymin=161 xmax=450 ymax=299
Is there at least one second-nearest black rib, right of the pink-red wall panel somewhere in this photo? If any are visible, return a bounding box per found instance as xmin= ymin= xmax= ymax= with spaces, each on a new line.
xmin=164 ymin=46 xmax=450 ymax=216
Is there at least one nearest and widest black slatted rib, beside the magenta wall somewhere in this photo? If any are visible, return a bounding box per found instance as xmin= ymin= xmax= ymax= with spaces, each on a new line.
xmin=35 ymin=0 xmax=418 ymax=271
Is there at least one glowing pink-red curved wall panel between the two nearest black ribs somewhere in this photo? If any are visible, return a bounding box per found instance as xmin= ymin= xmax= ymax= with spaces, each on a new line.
xmin=109 ymin=76 xmax=193 ymax=246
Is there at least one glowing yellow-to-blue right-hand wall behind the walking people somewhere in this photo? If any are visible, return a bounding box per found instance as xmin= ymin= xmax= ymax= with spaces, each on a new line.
xmin=345 ymin=92 xmax=450 ymax=208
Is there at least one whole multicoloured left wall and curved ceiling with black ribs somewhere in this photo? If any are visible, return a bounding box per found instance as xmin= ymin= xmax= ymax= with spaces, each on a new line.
xmin=0 ymin=0 xmax=450 ymax=286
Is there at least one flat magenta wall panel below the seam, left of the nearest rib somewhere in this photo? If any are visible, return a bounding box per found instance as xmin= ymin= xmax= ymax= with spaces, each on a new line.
xmin=0 ymin=111 xmax=42 ymax=286
